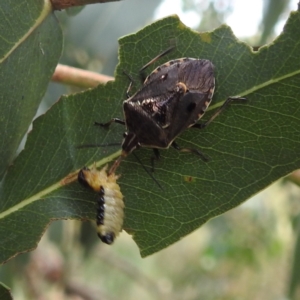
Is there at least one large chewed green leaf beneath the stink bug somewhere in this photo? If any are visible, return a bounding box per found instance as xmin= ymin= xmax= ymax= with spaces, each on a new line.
xmin=0 ymin=12 xmax=300 ymax=261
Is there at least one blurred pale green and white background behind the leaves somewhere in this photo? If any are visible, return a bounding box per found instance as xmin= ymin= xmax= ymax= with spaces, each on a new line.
xmin=0 ymin=0 xmax=300 ymax=300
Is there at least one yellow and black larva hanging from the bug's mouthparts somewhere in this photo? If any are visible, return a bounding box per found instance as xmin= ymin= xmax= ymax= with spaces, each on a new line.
xmin=78 ymin=165 xmax=124 ymax=245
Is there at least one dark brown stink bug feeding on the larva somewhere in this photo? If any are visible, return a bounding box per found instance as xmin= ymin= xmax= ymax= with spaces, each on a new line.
xmin=96 ymin=47 xmax=245 ymax=173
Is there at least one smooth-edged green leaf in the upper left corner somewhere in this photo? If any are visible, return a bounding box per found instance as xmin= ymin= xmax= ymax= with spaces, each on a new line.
xmin=0 ymin=0 xmax=62 ymax=179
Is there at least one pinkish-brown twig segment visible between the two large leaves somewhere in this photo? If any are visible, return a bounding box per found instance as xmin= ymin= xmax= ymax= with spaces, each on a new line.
xmin=52 ymin=64 xmax=114 ymax=88
